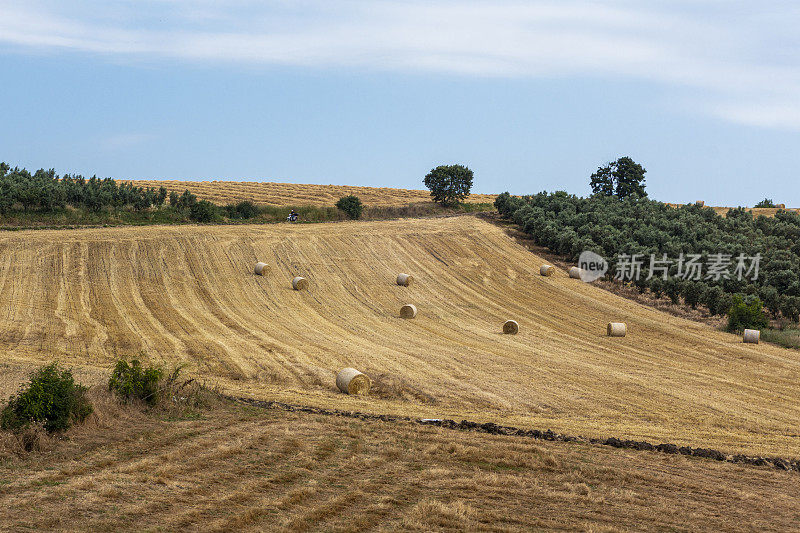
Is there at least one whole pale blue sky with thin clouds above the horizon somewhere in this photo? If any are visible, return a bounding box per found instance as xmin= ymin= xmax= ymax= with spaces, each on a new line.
xmin=0 ymin=0 xmax=800 ymax=206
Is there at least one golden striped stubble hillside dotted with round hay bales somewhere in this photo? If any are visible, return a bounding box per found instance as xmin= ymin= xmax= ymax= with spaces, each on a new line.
xmin=0 ymin=216 xmax=800 ymax=457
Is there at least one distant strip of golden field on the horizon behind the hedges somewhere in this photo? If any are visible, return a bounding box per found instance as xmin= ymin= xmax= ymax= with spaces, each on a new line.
xmin=120 ymin=180 xmax=497 ymax=207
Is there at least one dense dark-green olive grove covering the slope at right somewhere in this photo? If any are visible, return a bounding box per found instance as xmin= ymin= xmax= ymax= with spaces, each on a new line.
xmin=495 ymin=190 xmax=800 ymax=322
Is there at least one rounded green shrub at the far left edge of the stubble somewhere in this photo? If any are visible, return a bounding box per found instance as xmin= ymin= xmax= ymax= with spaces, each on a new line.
xmin=0 ymin=363 xmax=93 ymax=433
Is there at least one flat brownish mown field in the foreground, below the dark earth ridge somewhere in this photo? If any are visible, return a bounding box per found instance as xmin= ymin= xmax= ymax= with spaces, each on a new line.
xmin=0 ymin=391 xmax=800 ymax=531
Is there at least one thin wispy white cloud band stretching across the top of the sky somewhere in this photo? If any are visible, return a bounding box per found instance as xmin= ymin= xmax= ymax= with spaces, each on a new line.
xmin=0 ymin=0 xmax=800 ymax=129
